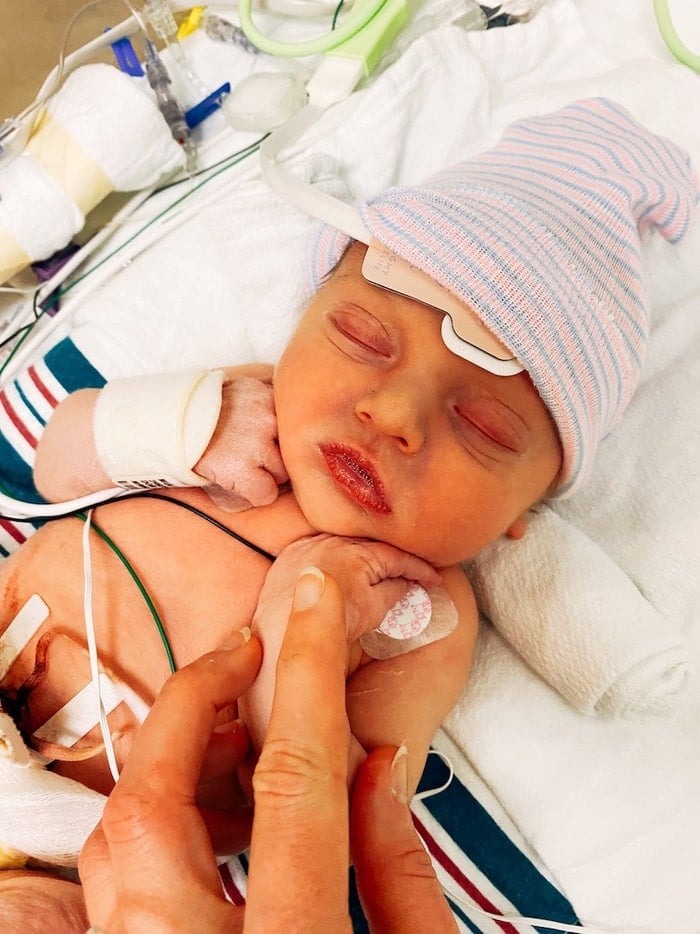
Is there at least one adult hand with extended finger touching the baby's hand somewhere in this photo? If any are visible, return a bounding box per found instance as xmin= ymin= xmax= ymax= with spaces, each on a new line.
xmin=80 ymin=572 xmax=456 ymax=934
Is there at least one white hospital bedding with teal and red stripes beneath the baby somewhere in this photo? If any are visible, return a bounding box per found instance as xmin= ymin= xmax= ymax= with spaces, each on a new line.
xmin=0 ymin=0 xmax=700 ymax=934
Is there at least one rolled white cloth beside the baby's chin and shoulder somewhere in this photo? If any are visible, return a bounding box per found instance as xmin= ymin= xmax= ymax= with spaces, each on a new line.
xmin=467 ymin=506 xmax=690 ymax=716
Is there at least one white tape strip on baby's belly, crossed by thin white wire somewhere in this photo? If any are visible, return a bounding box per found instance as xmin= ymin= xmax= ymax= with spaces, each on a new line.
xmin=32 ymin=672 xmax=149 ymax=747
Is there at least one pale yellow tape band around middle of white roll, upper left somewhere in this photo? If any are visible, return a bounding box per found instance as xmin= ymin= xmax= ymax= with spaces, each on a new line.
xmin=25 ymin=111 xmax=114 ymax=214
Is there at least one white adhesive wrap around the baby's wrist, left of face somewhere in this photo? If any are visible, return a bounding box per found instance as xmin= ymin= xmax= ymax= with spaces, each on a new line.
xmin=93 ymin=370 xmax=225 ymax=490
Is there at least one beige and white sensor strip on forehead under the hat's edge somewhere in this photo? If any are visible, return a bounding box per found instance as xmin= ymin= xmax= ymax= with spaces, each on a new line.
xmin=362 ymin=238 xmax=524 ymax=376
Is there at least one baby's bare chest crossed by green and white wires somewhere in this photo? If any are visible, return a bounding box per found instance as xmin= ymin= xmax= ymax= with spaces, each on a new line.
xmin=0 ymin=522 xmax=269 ymax=700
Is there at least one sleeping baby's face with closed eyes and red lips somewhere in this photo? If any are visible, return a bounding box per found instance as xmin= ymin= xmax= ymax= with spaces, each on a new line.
xmin=275 ymin=244 xmax=561 ymax=566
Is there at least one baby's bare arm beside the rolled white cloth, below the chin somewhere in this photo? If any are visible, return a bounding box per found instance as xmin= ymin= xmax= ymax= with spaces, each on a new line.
xmin=347 ymin=567 xmax=478 ymax=789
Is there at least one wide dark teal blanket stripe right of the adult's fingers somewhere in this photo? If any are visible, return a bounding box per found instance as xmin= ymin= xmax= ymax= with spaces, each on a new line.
xmin=419 ymin=756 xmax=581 ymax=932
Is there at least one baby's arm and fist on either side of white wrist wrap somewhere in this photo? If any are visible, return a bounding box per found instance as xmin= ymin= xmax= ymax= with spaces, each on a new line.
xmin=34 ymin=365 xmax=286 ymax=508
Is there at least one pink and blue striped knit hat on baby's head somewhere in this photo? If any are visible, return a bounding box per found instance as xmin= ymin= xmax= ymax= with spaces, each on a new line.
xmin=314 ymin=98 xmax=697 ymax=496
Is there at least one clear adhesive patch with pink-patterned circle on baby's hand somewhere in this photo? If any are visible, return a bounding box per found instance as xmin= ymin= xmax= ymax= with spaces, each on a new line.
xmin=360 ymin=583 xmax=459 ymax=659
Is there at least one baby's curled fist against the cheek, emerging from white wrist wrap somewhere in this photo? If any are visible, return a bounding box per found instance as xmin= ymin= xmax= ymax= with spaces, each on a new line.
xmin=194 ymin=376 xmax=288 ymax=510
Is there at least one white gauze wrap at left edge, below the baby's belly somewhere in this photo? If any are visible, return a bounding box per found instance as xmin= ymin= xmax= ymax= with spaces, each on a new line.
xmin=0 ymin=711 xmax=107 ymax=869
